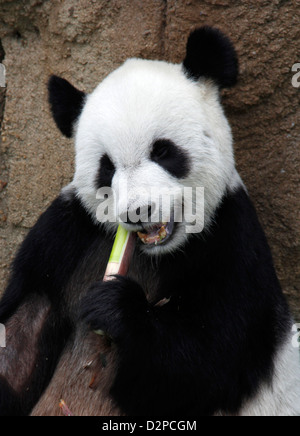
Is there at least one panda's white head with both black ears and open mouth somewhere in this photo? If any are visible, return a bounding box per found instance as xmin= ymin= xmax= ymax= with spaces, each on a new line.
xmin=49 ymin=27 xmax=241 ymax=255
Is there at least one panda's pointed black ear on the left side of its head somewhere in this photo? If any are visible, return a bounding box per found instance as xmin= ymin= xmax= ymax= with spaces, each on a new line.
xmin=48 ymin=76 xmax=85 ymax=138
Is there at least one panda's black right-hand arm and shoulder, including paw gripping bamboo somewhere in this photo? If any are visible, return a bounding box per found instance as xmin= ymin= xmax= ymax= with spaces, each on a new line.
xmin=83 ymin=189 xmax=290 ymax=416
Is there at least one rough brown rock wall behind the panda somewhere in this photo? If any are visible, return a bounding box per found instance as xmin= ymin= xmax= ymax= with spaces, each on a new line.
xmin=0 ymin=0 xmax=300 ymax=321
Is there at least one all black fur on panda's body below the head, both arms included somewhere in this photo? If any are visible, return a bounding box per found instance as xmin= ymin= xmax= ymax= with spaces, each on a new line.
xmin=0 ymin=189 xmax=290 ymax=416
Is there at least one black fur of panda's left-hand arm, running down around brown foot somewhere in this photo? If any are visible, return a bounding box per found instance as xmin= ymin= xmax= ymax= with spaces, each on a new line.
xmin=0 ymin=194 xmax=111 ymax=416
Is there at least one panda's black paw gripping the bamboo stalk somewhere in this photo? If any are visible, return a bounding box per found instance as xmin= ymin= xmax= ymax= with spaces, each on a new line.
xmin=80 ymin=276 xmax=150 ymax=341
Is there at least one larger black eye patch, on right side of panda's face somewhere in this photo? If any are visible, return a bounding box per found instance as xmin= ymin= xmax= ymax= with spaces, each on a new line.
xmin=150 ymin=139 xmax=190 ymax=179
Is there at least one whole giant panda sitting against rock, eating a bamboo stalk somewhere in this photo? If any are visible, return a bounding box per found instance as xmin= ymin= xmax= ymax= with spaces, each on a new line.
xmin=0 ymin=27 xmax=300 ymax=417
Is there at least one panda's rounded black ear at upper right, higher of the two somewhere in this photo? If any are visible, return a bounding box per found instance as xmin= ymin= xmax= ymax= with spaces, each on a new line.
xmin=183 ymin=26 xmax=239 ymax=88
